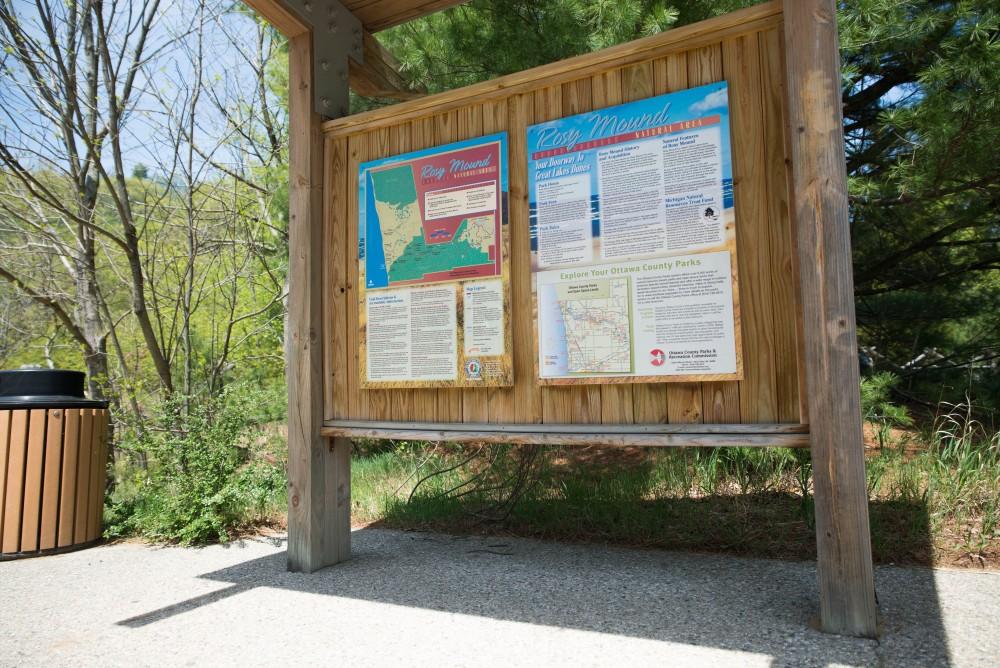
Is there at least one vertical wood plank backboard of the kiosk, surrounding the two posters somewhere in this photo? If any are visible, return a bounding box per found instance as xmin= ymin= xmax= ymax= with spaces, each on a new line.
xmin=323 ymin=3 xmax=804 ymax=424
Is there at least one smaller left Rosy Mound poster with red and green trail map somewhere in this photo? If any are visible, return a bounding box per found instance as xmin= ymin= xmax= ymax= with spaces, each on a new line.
xmin=358 ymin=133 xmax=513 ymax=389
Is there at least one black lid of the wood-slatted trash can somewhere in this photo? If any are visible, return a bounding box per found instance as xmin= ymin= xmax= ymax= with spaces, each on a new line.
xmin=0 ymin=369 xmax=108 ymax=409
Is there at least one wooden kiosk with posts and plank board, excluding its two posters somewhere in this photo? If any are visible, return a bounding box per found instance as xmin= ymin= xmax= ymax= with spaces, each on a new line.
xmin=247 ymin=0 xmax=876 ymax=636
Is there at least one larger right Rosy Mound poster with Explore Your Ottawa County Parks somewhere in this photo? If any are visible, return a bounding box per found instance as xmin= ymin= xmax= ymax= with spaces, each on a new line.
xmin=528 ymin=82 xmax=742 ymax=384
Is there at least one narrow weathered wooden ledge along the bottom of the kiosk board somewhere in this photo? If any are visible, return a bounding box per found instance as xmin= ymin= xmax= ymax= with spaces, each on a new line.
xmin=321 ymin=420 xmax=809 ymax=448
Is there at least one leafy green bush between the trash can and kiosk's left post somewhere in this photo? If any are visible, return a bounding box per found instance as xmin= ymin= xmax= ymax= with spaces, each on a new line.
xmin=107 ymin=387 xmax=286 ymax=544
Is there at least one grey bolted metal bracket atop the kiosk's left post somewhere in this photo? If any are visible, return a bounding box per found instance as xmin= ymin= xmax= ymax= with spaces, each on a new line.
xmin=285 ymin=0 xmax=365 ymax=118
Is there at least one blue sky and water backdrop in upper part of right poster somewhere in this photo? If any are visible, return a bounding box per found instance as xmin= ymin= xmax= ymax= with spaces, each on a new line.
xmin=527 ymin=81 xmax=734 ymax=251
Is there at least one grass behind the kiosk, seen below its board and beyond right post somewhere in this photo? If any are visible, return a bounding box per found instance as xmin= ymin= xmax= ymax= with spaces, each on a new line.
xmin=352 ymin=414 xmax=1000 ymax=565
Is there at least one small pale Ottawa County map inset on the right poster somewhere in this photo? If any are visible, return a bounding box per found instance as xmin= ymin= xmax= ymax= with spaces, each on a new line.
xmin=556 ymin=278 xmax=632 ymax=374
